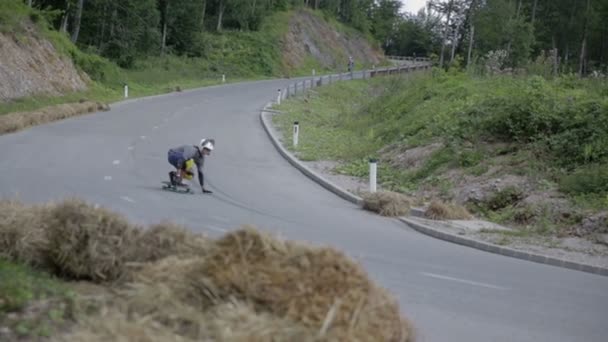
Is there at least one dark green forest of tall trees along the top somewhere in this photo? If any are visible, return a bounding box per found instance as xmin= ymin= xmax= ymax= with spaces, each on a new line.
xmin=25 ymin=0 xmax=608 ymax=75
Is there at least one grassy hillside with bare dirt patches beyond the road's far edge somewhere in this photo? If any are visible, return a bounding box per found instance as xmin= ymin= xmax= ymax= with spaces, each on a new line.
xmin=0 ymin=2 xmax=383 ymax=114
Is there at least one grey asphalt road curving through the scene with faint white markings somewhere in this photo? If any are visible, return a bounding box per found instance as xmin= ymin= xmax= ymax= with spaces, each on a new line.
xmin=0 ymin=80 xmax=608 ymax=342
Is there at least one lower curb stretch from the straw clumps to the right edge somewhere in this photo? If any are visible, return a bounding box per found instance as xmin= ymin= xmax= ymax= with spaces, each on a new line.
xmin=399 ymin=217 xmax=608 ymax=276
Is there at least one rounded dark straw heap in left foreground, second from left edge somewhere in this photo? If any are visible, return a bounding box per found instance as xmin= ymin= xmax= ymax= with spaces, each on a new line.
xmin=48 ymin=199 xmax=141 ymax=282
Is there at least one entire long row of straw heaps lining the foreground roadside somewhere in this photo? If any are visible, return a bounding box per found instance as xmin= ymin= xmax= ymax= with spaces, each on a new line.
xmin=0 ymin=199 xmax=414 ymax=342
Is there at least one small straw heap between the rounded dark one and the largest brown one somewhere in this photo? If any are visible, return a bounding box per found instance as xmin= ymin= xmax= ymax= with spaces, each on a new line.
xmin=133 ymin=222 xmax=211 ymax=262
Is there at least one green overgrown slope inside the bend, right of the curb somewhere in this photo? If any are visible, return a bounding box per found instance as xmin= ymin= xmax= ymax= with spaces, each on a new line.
xmin=275 ymin=69 xmax=608 ymax=243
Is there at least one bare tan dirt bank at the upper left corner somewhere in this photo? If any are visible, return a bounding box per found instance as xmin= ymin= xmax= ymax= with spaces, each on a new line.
xmin=0 ymin=24 xmax=87 ymax=102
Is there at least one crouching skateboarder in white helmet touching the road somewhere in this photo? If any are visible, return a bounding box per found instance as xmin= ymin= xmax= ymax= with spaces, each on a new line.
xmin=167 ymin=139 xmax=215 ymax=194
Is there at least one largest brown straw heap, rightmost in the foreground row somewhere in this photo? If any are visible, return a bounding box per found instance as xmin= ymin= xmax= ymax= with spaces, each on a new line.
xmin=193 ymin=226 xmax=411 ymax=341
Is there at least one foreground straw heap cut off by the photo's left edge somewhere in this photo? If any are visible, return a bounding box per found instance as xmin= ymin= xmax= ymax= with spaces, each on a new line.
xmin=0 ymin=200 xmax=49 ymax=268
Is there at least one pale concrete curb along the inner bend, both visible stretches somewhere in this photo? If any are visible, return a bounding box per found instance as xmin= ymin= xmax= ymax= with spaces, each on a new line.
xmin=260 ymin=102 xmax=608 ymax=276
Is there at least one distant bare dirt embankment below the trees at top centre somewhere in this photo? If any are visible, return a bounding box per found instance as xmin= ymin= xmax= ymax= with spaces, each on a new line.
xmin=283 ymin=11 xmax=384 ymax=70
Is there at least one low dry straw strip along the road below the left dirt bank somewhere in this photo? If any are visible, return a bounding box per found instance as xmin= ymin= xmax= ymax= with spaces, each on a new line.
xmin=0 ymin=101 xmax=109 ymax=134
